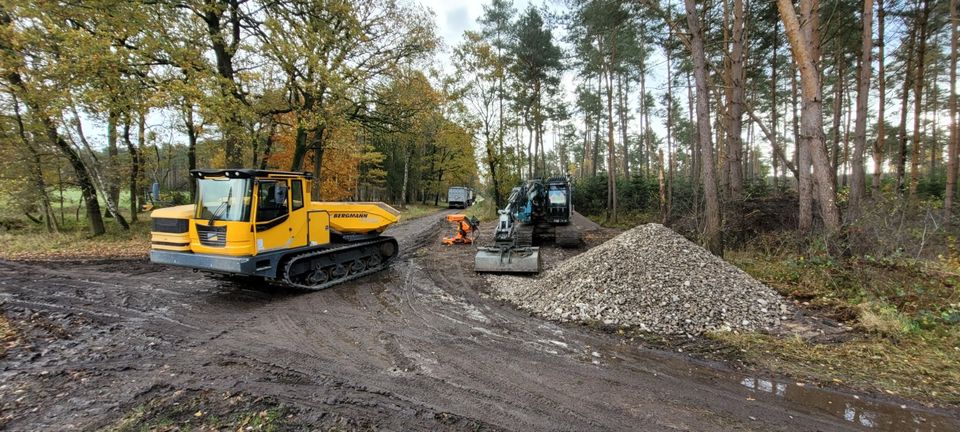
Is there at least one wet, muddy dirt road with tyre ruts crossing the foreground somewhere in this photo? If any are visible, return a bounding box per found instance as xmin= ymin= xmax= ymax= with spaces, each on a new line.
xmin=0 ymin=211 xmax=960 ymax=431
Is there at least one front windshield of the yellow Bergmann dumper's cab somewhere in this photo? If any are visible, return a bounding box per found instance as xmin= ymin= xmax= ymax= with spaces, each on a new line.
xmin=197 ymin=178 xmax=252 ymax=222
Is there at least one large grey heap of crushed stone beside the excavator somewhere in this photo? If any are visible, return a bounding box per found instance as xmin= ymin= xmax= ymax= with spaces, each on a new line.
xmin=491 ymin=224 xmax=790 ymax=335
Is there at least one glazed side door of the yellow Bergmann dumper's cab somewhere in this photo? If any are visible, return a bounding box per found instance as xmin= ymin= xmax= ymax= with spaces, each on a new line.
xmin=253 ymin=179 xmax=303 ymax=253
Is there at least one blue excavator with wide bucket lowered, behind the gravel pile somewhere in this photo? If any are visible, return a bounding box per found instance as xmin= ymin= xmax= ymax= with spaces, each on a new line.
xmin=474 ymin=177 xmax=583 ymax=273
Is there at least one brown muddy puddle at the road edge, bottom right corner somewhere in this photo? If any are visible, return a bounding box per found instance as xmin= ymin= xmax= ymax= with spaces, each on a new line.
xmin=740 ymin=377 xmax=960 ymax=431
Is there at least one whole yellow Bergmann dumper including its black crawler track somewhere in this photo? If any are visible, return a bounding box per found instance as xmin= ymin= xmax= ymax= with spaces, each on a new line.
xmin=150 ymin=169 xmax=400 ymax=290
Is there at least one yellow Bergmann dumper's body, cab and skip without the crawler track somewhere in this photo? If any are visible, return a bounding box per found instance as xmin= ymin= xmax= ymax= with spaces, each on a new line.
xmin=150 ymin=170 xmax=400 ymax=286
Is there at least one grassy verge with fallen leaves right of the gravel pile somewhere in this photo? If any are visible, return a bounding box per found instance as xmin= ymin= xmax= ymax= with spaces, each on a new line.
xmin=728 ymin=251 xmax=960 ymax=405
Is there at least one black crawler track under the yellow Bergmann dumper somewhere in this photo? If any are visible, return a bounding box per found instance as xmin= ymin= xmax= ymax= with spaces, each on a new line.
xmin=277 ymin=236 xmax=399 ymax=291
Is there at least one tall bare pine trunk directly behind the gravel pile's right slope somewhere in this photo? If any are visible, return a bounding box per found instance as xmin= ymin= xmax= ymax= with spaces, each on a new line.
xmin=684 ymin=0 xmax=723 ymax=255
